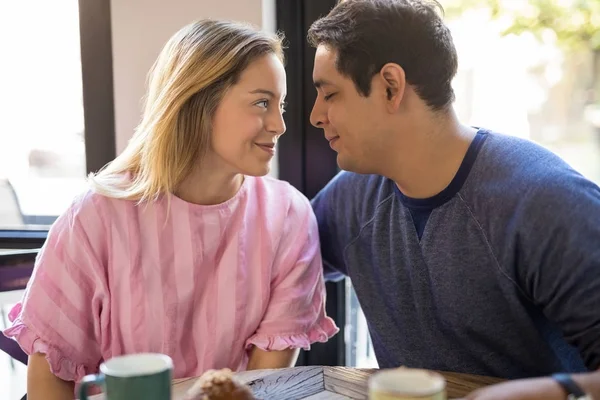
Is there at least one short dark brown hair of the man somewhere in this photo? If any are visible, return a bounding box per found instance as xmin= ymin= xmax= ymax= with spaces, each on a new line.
xmin=308 ymin=0 xmax=458 ymax=110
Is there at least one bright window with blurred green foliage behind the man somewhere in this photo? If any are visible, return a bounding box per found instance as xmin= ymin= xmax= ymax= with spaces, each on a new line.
xmin=450 ymin=0 xmax=600 ymax=183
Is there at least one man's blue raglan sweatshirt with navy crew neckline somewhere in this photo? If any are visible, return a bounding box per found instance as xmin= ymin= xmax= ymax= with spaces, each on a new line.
xmin=312 ymin=130 xmax=600 ymax=379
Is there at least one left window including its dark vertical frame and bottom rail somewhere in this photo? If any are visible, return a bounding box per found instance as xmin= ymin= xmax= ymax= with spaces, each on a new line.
xmin=0 ymin=0 xmax=115 ymax=248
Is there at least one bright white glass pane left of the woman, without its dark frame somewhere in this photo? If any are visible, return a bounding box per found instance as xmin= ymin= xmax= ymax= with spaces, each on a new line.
xmin=0 ymin=0 xmax=86 ymax=228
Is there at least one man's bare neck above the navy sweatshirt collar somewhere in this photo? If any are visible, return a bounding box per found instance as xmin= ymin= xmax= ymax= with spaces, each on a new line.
xmin=386 ymin=112 xmax=477 ymax=199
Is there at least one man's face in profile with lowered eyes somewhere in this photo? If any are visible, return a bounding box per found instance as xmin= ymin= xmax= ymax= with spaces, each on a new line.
xmin=310 ymin=45 xmax=388 ymax=173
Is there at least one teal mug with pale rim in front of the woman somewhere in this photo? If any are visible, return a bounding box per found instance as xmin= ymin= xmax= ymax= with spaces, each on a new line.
xmin=79 ymin=353 xmax=173 ymax=400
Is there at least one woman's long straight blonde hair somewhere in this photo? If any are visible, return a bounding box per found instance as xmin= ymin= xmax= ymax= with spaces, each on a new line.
xmin=88 ymin=19 xmax=283 ymax=202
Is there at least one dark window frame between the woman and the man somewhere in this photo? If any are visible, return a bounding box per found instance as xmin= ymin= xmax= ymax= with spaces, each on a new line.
xmin=276 ymin=0 xmax=346 ymax=366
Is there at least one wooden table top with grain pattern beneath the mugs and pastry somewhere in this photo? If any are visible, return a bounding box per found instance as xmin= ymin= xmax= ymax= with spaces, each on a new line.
xmin=173 ymin=367 xmax=502 ymax=400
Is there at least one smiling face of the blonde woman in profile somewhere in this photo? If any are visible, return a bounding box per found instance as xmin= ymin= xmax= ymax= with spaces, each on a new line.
xmin=211 ymin=54 xmax=286 ymax=176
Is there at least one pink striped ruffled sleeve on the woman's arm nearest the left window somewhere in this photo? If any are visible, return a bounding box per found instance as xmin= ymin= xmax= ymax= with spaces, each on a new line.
xmin=4 ymin=194 xmax=107 ymax=382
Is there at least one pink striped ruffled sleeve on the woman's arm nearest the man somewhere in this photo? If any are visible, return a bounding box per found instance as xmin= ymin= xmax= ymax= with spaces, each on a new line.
xmin=246 ymin=188 xmax=339 ymax=351
